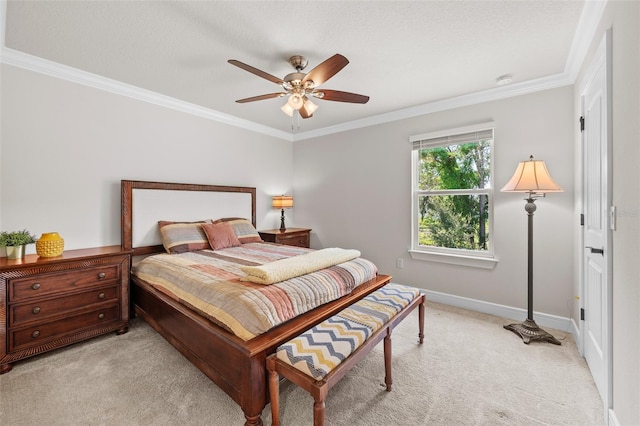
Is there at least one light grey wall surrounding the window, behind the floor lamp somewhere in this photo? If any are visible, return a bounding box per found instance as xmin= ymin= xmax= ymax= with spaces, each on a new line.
xmin=294 ymin=86 xmax=577 ymax=319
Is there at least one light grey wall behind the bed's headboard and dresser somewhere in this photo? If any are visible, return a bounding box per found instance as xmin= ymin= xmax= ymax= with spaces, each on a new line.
xmin=0 ymin=64 xmax=293 ymax=254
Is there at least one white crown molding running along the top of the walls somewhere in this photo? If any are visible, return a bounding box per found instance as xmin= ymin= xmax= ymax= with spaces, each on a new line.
xmin=0 ymin=0 xmax=607 ymax=141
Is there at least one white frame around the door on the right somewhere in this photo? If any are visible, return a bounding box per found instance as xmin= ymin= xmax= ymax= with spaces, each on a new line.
xmin=578 ymin=28 xmax=615 ymax=424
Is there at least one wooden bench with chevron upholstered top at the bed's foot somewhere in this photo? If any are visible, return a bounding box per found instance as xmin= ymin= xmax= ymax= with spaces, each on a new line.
xmin=267 ymin=283 xmax=425 ymax=426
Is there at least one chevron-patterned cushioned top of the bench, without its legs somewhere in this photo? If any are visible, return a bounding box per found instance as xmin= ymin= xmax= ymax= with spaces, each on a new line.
xmin=277 ymin=283 xmax=420 ymax=380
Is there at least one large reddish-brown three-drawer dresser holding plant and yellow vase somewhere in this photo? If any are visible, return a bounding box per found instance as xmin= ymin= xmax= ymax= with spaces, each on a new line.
xmin=0 ymin=246 xmax=131 ymax=374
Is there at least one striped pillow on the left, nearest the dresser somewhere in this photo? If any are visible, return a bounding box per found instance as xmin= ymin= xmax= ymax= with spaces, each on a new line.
xmin=158 ymin=220 xmax=211 ymax=254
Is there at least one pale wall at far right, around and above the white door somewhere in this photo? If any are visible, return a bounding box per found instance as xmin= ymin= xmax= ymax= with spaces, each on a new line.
xmin=574 ymin=1 xmax=640 ymax=425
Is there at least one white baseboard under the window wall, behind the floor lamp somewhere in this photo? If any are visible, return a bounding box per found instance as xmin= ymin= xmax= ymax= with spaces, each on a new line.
xmin=410 ymin=290 xmax=579 ymax=332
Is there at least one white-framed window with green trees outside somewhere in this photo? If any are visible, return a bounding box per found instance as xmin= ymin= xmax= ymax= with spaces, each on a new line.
xmin=410 ymin=123 xmax=493 ymax=267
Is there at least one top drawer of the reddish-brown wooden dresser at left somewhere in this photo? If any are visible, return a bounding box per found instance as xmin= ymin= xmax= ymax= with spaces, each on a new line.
xmin=9 ymin=265 xmax=121 ymax=302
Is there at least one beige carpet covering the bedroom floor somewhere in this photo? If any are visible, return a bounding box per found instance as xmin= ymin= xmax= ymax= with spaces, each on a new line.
xmin=0 ymin=303 xmax=604 ymax=426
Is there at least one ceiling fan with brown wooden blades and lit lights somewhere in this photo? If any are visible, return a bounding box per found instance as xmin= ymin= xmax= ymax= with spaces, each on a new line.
xmin=227 ymin=53 xmax=369 ymax=118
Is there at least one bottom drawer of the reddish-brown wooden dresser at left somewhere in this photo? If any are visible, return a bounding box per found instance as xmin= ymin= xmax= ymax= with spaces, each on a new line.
xmin=9 ymin=301 xmax=120 ymax=351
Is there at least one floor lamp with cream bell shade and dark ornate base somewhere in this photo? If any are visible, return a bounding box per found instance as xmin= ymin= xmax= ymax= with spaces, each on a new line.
xmin=501 ymin=155 xmax=562 ymax=345
